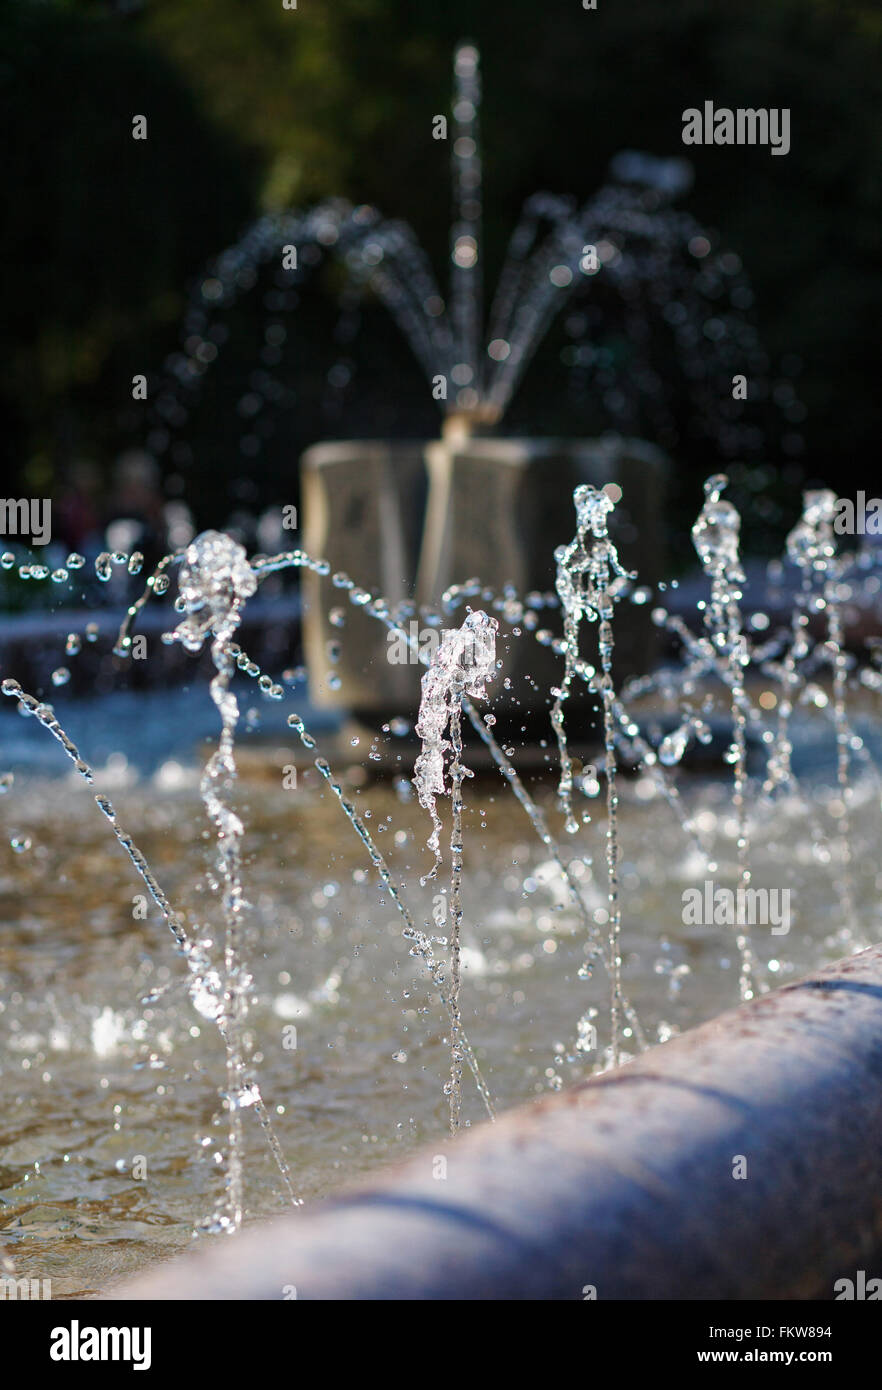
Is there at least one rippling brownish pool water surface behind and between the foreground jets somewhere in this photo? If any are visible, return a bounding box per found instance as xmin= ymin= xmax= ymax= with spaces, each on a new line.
xmin=0 ymin=689 xmax=882 ymax=1297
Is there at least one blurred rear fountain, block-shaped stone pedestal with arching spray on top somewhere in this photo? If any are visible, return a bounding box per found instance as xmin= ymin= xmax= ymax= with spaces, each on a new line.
xmin=141 ymin=43 xmax=794 ymax=723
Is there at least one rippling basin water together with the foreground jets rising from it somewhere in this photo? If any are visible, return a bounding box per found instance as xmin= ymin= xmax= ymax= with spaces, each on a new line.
xmin=0 ymin=477 xmax=879 ymax=1287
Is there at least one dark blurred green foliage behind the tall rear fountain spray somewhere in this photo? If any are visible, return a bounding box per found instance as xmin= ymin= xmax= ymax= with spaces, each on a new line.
xmin=0 ymin=0 xmax=882 ymax=536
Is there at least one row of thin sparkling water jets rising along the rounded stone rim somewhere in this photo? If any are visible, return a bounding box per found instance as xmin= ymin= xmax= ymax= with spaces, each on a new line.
xmin=3 ymin=475 xmax=878 ymax=1262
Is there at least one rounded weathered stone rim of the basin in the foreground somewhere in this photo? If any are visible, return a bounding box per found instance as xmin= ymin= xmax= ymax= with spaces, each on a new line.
xmin=111 ymin=947 xmax=882 ymax=1300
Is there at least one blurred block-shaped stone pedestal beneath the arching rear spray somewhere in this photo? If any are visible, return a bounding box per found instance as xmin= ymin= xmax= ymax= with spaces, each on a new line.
xmin=301 ymin=435 xmax=668 ymax=723
